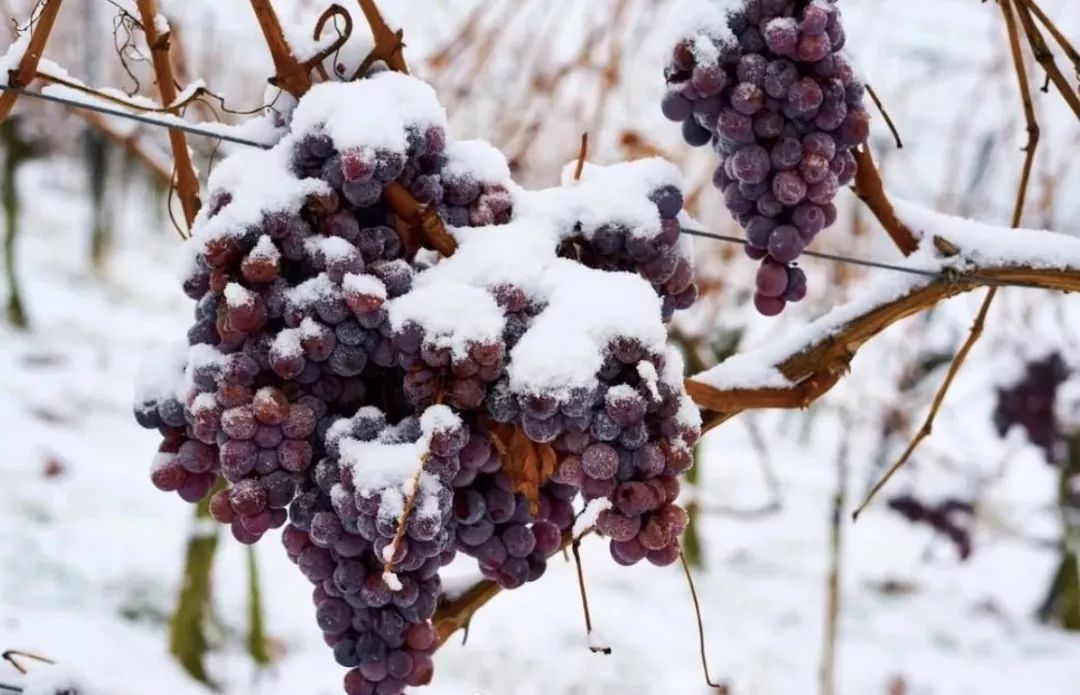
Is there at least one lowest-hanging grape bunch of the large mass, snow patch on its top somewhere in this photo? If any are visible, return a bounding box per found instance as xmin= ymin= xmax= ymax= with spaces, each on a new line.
xmin=282 ymin=406 xmax=467 ymax=694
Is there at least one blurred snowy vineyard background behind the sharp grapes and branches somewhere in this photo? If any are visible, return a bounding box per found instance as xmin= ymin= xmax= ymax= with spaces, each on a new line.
xmin=0 ymin=0 xmax=1080 ymax=695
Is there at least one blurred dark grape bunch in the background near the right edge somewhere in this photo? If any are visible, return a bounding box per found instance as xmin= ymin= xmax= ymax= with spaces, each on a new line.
xmin=994 ymin=353 xmax=1070 ymax=463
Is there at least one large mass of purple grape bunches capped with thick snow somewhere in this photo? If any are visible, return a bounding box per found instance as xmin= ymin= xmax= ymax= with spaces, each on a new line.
xmin=135 ymin=72 xmax=700 ymax=695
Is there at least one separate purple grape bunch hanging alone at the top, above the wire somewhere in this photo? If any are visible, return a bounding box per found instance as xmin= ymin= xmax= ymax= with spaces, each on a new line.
xmin=661 ymin=0 xmax=869 ymax=316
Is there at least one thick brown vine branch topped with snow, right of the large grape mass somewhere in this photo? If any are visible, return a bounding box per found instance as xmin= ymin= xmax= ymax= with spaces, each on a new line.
xmin=686 ymin=201 xmax=1080 ymax=426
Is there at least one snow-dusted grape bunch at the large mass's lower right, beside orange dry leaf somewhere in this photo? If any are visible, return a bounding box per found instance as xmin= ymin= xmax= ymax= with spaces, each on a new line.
xmin=540 ymin=340 xmax=699 ymax=565
